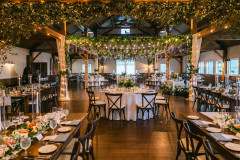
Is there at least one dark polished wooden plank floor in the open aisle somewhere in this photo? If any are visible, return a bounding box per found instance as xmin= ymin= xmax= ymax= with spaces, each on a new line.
xmin=61 ymin=87 xmax=195 ymax=160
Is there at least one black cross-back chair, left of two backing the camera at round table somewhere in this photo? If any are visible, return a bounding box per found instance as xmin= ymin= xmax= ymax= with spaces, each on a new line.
xmin=105 ymin=93 xmax=126 ymax=125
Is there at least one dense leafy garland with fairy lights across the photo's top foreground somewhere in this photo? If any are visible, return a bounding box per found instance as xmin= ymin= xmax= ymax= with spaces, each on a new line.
xmin=0 ymin=0 xmax=240 ymax=46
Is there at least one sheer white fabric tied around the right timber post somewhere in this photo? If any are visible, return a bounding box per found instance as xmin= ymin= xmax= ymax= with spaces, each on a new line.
xmin=189 ymin=34 xmax=202 ymax=101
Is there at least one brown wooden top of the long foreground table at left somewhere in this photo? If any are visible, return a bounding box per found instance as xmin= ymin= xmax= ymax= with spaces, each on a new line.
xmin=6 ymin=113 xmax=87 ymax=160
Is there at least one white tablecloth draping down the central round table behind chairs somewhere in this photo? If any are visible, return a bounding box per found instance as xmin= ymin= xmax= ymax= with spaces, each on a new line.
xmin=100 ymin=91 xmax=156 ymax=121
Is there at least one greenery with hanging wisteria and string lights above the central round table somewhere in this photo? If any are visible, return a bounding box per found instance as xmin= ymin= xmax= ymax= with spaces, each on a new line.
xmin=66 ymin=35 xmax=189 ymax=59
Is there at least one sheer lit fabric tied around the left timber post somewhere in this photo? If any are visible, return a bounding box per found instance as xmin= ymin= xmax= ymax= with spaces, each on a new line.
xmin=56 ymin=36 xmax=70 ymax=101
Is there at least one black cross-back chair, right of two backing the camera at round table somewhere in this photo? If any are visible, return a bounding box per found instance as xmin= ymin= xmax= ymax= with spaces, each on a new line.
xmin=136 ymin=92 xmax=158 ymax=122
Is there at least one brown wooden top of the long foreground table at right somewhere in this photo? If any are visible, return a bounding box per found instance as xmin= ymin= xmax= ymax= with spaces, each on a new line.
xmin=181 ymin=112 xmax=240 ymax=160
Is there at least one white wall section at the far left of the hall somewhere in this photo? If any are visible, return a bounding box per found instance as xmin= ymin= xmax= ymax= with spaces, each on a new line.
xmin=0 ymin=47 xmax=29 ymax=79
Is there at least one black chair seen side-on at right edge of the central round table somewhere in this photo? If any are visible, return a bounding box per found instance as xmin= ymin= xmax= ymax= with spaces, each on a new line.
xmin=155 ymin=90 xmax=172 ymax=119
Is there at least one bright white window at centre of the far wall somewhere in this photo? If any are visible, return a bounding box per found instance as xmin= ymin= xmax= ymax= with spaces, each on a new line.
xmin=116 ymin=60 xmax=135 ymax=75
